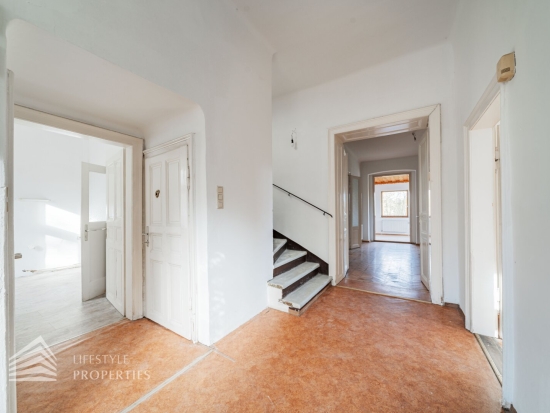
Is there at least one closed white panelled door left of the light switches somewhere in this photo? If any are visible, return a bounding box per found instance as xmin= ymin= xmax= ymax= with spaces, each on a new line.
xmin=145 ymin=145 xmax=191 ymax=339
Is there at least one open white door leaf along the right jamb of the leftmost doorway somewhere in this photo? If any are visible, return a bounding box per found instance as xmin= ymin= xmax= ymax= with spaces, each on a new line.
xmin=105 ymin=149 xmax=124 ymax=315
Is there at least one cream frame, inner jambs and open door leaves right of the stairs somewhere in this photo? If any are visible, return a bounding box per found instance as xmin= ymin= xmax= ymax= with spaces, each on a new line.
xmin=329 ymin=105 xmax=443 ymax=304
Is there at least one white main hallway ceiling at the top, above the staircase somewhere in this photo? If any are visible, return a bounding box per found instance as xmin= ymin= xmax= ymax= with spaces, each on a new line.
xmin=233 ymin=0 xmax=457 ymax=96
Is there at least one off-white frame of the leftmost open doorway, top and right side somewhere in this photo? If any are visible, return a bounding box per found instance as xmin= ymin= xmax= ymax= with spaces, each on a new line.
xmin=12 ymin=105 xmax=143 ymax=320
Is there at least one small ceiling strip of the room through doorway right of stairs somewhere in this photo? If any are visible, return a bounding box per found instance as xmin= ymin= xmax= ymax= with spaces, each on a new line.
xmin=344 ymin=131 xmax=422 ymax=162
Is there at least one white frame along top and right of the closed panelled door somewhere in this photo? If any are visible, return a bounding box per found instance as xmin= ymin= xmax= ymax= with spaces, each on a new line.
xmin=143 ymin=133 xmax=199 ymax=343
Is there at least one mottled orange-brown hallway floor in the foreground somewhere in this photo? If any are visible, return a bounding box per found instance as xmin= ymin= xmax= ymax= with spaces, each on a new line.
xmin=17 ymin=288 xmax=501 ymax=413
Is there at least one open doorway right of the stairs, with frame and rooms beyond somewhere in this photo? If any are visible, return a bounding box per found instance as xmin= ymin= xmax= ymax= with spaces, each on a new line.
xmin=329 ymin=105 xmax=443 ymax=304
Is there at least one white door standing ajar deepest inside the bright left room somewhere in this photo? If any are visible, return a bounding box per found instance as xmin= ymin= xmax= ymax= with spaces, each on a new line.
xmin=80 ymin=162 xmax=107 ymax=301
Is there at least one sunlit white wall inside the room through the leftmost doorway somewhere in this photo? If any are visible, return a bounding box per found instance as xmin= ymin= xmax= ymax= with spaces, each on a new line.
xmin=14 ymin=123 xmax=120 ymax=276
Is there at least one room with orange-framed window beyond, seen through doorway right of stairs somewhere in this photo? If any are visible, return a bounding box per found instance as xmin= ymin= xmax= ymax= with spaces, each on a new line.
xmin=339 ymin=133 xmax=431 ymax=302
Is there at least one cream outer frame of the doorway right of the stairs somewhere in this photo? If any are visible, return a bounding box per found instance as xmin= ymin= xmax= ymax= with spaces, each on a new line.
xmin=328 ymin=104 xmax=443 ymax=304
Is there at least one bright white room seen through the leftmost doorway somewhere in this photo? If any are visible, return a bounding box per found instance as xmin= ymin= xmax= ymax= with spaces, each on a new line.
xmin=14 ymin=121 xmax=123 ymax=350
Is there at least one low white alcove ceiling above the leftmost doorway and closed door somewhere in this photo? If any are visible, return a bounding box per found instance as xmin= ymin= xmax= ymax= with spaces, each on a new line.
xmin=7 ymin=21 xmax=197 ymax=138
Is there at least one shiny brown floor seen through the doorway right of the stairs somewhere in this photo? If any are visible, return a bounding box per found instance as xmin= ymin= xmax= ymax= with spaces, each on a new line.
xmin=338 ymin=242 xmax=431 ymax=302
